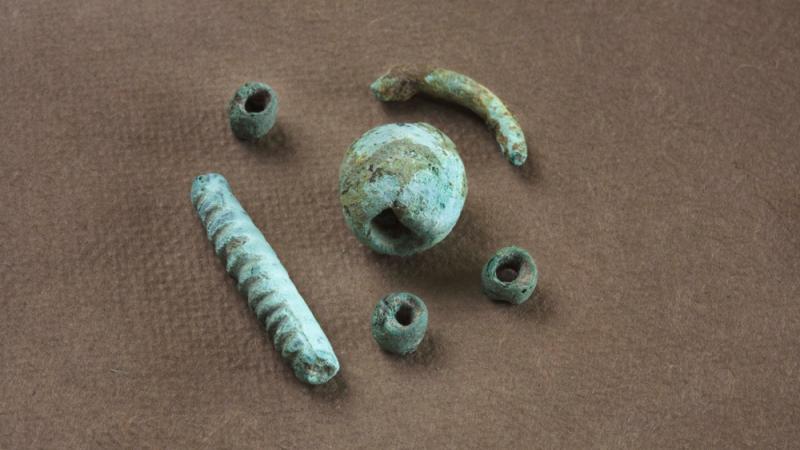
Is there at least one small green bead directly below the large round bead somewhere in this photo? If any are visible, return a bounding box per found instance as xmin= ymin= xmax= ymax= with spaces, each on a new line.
xmin=371 ymin=292 xmax=428 ymax=355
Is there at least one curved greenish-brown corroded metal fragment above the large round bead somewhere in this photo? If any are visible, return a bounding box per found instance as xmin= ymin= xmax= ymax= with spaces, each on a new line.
xmin=370 ymin=66 xmax=528 ymax=166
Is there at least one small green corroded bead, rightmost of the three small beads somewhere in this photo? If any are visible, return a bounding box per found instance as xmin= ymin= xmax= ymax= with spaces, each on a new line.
xmin=481 ymin=246 xmax=539 ymax=305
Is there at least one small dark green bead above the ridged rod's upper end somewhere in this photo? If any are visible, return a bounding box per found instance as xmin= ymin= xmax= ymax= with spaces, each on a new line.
xmin=228 ymin=81 xmax=278 ymax=142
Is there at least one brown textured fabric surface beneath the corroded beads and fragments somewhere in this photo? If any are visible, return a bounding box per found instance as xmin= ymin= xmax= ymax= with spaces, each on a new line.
xmin=0 ymin=0 xmax=800 ymax=448
